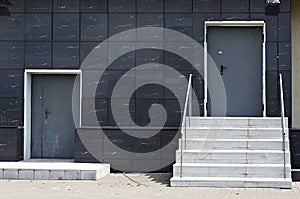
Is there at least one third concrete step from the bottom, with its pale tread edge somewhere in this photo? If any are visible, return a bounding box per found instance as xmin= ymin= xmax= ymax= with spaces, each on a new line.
xmin=176 ymin=150 xmax=290 ymax=164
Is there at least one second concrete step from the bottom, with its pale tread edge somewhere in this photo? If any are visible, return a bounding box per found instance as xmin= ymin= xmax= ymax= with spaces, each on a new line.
xmin=173 ymin=163 xmax=291 ymax=178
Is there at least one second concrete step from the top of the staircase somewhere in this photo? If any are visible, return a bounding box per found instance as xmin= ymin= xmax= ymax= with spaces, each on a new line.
xmin=182 ymin=127 xmax=288 ymax=139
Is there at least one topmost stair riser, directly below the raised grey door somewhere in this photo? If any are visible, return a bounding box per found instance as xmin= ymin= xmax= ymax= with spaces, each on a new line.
xmin=186 ymin=118 xmax=288 ymax=128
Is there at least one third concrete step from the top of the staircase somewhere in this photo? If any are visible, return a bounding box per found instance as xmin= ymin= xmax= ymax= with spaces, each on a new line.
xmin=179 ymin=139 xmax=289 ymax=151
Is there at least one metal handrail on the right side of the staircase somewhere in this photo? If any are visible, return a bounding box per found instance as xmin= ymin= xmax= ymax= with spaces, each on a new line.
xmin=279 ymin=74 xmax=286 ymax=178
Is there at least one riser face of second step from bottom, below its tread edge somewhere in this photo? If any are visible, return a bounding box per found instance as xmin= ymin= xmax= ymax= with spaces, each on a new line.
xmin=173 ymin=166 xmax=291 ymax=178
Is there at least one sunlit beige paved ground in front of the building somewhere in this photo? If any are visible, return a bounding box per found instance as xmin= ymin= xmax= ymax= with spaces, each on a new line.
xmin=0 ymin=174 xmax=300 ymax=199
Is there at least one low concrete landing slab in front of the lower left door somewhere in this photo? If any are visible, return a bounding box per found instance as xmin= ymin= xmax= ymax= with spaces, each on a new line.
xmin=0 ymin=160 xmax=110 ymax=180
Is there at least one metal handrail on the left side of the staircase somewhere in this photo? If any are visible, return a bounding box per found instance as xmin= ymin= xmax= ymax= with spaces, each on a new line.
xmin=180 ymin=74 xmax=192 ymax=178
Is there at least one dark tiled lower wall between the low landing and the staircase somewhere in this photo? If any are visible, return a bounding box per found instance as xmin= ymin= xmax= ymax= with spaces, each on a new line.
xmin=74 ymin=127 xmax=179 ymax=172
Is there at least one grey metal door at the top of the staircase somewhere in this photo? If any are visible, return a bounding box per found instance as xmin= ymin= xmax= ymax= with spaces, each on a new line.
xmin=207 ymin=27 xmax=263 ymax=116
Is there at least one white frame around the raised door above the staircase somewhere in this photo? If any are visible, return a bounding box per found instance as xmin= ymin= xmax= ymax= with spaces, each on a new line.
xmin=204 ymin=21 xmax=267 ymax=117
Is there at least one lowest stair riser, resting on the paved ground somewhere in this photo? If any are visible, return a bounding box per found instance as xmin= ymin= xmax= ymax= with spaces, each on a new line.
xmin=171 ymin=179 xmax=292 ymax=189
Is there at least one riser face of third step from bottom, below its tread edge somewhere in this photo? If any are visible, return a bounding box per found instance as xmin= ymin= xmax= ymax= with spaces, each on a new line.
xmin=176 ymin=151 xmax=290 ymax=164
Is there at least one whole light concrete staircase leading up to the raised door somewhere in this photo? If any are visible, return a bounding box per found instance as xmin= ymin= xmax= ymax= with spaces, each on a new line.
xmin=171 ymin=117 xmax=292 ymax=188
